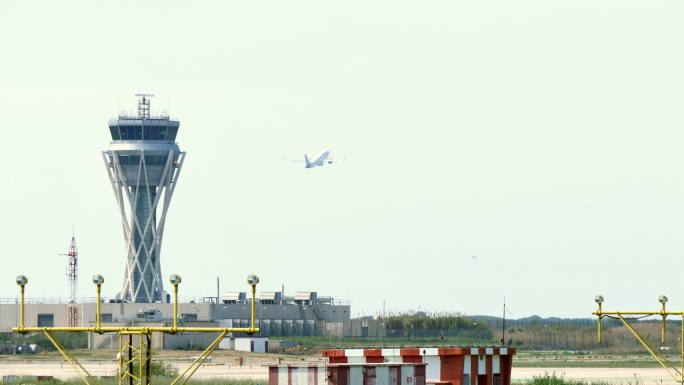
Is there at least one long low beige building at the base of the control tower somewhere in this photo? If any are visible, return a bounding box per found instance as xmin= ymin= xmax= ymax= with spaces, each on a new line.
xmin=0 ymin=291 xmax=352 ymax=348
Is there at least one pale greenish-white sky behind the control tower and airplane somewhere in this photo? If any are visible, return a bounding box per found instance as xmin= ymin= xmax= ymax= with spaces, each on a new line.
xmin=0 ymin=0 xmax=684 ymax=318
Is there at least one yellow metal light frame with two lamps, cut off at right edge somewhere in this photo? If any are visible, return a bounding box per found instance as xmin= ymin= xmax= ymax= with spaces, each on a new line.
xmin=592 ymin=298 xmax=684 ymax=385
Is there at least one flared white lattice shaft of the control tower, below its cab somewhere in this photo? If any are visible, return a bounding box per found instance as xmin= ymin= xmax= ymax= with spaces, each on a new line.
xmin=102 ymin=149 xmax=185 ymax=303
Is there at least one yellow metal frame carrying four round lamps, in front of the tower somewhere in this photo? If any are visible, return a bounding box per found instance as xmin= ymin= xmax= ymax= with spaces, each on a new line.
xmin=12 ymin=274 xmax=259 ymax=385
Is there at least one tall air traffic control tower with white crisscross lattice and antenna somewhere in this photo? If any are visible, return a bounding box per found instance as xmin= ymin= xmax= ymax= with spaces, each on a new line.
xmin=102 ymin=94 xmax=185 ymax=303
